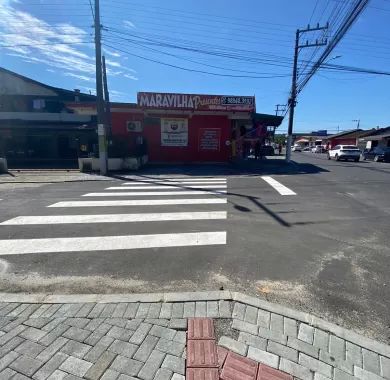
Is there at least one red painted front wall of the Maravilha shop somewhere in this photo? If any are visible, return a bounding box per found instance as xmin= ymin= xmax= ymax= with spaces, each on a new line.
xmin=112 ymin=113 xmax=231 ymax=163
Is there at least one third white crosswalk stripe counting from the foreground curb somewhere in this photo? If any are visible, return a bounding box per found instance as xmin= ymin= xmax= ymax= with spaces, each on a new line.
xmin=47 ymin=197 xmax=227 ymax=207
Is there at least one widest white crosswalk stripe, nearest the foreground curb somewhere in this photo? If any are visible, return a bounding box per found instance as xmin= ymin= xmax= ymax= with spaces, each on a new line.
xmin=0 ymin=231 xmax=226 ymax=255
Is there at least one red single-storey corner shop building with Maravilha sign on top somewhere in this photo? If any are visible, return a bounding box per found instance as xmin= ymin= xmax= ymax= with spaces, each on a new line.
xmin=68 ymin=92 xmax=282 ymax=163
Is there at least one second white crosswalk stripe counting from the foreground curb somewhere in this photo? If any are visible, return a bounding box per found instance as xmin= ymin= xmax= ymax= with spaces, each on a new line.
xmin=0 ymin=211 xmax=227 ymax=226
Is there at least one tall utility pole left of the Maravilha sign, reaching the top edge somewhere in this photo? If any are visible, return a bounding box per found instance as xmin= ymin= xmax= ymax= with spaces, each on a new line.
xmin=95 ymin=0 xmax=107 ymax=175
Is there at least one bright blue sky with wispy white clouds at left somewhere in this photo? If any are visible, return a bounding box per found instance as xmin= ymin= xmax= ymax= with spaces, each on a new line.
xmin=0 ymin=0 xmax=390 ymax=132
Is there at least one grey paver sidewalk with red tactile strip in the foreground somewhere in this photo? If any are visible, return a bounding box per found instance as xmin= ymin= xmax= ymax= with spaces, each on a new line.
xmin=0 ymin=292 xmax=390 ymax=380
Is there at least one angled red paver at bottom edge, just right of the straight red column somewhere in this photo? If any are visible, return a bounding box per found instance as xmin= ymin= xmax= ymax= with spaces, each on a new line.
xmin=221 ymin=352 xmax=258 ymax=380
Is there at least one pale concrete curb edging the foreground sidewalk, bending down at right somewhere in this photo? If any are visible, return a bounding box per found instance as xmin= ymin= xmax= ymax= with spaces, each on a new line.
xmin=0 ymin=291 xmax=390 ymax=358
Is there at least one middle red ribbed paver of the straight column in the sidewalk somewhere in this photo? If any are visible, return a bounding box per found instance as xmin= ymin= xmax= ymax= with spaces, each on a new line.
xmin=187 ymin=340 xmax=218 ymax=368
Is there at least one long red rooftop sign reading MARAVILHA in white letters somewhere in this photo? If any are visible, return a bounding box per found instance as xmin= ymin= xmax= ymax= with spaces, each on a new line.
xmin=137 ymin=92 xmax=256 ymax=112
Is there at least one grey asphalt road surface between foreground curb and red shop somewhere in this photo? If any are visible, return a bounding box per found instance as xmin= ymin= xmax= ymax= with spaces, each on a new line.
xmin=0 ymin=153 xmax=390 ymax=342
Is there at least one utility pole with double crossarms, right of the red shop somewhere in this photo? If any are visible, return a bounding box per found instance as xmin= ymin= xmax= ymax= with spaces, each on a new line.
xmin=286 ymin=24 xmax=329 ymax=162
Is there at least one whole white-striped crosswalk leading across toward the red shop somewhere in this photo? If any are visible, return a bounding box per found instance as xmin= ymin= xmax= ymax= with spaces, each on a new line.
xmin=0 ymin=176 xmax=227 ymax=255
